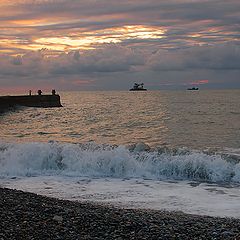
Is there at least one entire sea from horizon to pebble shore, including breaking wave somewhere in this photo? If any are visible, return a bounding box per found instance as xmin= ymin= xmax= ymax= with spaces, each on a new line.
xmin=0 ymin=90 xmax=240 ymax=218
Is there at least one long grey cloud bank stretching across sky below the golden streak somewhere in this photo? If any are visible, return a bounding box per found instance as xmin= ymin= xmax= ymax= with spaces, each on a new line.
xmin=0 ymin=43 xmax=240 ymax=82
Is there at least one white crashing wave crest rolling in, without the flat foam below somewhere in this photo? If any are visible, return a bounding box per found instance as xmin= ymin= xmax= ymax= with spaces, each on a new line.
xmin=0 ymin=141 xmax=240 ymax=183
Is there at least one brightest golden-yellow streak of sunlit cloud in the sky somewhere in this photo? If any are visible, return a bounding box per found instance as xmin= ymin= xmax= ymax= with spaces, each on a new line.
xmin=1 ymin=25 xmax=166 ymax=51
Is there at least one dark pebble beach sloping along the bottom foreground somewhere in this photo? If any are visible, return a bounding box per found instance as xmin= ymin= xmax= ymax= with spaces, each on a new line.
xmin=0 ymin=188 xmax=240 ymax=240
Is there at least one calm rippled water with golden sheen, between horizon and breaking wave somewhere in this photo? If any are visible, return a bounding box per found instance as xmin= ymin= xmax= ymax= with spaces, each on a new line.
xmin=0 ymin=90 xmax=240 ymax=148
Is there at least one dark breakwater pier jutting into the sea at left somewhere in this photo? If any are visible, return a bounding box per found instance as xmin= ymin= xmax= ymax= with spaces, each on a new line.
xmin=0 ymin=94 xmax=62 ymax=112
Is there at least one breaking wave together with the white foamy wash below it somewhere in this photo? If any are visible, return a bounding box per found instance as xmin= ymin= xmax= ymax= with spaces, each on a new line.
xmin=0 ymin=142 xmax=240 ymax=218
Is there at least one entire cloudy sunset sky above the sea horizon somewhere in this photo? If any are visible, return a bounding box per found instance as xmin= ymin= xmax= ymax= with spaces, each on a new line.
xmin=0 ymin=0 xmax=240 ymax=93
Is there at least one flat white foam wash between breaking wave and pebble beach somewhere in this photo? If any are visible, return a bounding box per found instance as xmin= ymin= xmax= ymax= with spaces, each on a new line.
xmin=0 ymin=176 xmax=240 ymax=218
